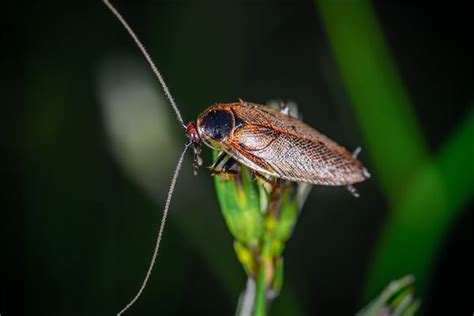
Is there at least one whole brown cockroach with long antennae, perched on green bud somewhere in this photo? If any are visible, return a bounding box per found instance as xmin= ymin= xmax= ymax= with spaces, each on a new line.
xmin=103 ymin=0 xmax=370 ymax=315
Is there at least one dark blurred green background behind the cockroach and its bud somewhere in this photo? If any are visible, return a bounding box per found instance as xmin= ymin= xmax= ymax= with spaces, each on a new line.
xmin=0 ymin=0 xmax=474 ymax=315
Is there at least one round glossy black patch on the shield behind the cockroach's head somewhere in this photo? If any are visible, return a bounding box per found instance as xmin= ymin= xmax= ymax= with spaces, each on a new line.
xmin=200 ymin=110 xmax=233 ymax=140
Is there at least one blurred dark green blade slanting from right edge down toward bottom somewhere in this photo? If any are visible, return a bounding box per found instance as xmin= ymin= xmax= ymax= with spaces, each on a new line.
xmin=365 ymin=107 xmax=474 ymax=297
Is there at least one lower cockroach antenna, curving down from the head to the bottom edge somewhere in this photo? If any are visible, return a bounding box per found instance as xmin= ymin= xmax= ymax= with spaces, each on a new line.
xmin=117 ymin=142 xmax=192 ymax=316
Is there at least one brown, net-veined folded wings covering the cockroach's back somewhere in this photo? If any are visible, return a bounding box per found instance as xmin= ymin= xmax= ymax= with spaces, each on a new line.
xmin=220 ymin=103 xmax=369 ymax=185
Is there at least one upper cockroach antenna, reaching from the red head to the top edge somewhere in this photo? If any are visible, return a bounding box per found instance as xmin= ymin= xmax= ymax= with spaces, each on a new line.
xmin=103 ymin=0 xmax=186 ymax=129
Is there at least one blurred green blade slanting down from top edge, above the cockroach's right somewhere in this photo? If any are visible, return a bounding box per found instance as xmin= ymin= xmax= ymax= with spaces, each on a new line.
xmin=316 ymin=0 xmax=427 ymax=201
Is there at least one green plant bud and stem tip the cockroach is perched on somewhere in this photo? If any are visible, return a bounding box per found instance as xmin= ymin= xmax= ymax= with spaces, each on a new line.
xmin=214 ymin=151 xmax=303 ymax=315
